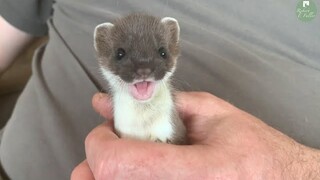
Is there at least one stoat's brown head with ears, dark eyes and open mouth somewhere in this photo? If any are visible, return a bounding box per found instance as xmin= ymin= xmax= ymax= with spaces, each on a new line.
xmin=94 ymin=14 xmax=180 ymax=101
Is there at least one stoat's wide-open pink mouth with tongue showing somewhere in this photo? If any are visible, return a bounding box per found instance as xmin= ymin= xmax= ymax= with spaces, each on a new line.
xmin=129 ymin=81 xmax=155 ymax=101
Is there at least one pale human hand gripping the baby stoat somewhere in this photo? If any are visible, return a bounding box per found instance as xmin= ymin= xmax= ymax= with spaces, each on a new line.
xmin=71 ymin=92 xmax=320 ymax=180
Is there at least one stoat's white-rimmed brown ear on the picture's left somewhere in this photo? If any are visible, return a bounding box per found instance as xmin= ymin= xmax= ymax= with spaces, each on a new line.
xmin=94 ymin=22 xmax=114 ymax=55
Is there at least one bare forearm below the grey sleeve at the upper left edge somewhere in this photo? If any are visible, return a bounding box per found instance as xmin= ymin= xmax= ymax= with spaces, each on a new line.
xmin=0 ymin=16 xmax=33 ymax=75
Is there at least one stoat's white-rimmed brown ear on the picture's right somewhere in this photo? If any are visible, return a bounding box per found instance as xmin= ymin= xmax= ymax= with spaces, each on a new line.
xmin=161 ymin=17 xmax=180 ymax=44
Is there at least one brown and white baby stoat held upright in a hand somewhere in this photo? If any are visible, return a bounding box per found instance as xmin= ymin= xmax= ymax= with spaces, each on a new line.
xmin=94 ymin=14 xmax=186 ymax=144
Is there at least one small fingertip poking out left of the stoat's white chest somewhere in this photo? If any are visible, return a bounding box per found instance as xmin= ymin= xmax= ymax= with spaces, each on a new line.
xmin=92 ymin=93 xmax=113 ymax=119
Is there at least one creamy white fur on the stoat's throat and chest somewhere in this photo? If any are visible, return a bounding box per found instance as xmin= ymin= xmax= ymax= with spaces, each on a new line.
xmin=101 ymin=68 xmax=174 ymax=142
